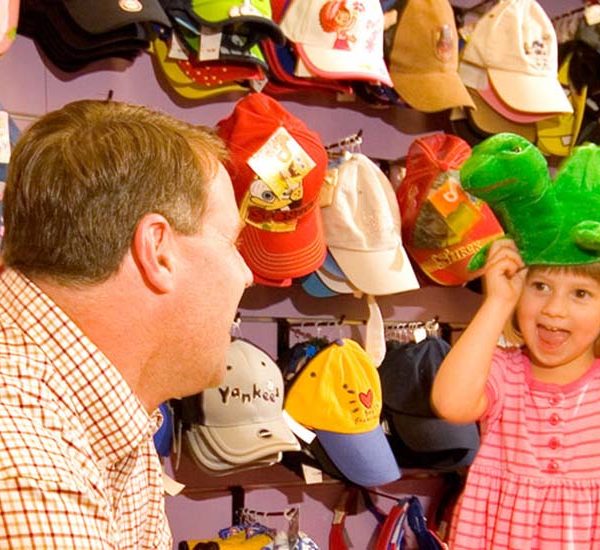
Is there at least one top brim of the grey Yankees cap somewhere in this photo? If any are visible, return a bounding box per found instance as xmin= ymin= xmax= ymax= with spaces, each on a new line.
xmin=196 ymin=417 xmax=300 ymax=464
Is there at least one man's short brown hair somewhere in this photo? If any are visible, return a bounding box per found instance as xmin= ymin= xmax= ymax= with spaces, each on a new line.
xmin=3 ymin=100 xmax=225 ymax=285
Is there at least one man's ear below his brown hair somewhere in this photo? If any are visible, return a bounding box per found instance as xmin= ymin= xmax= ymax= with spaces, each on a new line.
xmin=132 ymin=213 xmax=175 ymax=293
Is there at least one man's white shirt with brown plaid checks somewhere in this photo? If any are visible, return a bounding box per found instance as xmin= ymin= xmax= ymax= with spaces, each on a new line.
xmin=0 ymin=269 xmax=172 ymax=550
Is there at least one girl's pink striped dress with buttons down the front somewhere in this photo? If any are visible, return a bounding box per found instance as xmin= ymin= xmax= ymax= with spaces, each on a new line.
xmin=449 ymin=349 xmax=600 ymax=550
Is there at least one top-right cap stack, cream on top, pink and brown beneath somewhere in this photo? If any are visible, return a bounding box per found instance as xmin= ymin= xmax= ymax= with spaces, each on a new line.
xmin=459 ymin=0 xmax=573 ymax=151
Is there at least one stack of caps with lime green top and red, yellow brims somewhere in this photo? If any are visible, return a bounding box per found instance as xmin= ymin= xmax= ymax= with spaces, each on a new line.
xmin=153 ymin=0 xmax=283 ymax=99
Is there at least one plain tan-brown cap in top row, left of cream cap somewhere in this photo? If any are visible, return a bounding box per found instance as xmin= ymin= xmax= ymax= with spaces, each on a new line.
xmin=389 ymin=0 xmax=473 ymax=112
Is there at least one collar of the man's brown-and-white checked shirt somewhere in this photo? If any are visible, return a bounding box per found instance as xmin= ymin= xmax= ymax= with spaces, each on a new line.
xmin=0 ymin=268 xmax=160 ymax=464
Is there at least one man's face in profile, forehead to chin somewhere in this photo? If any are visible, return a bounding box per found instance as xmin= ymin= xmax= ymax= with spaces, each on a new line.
xmin=165 ymin=166 xmax=252 ymax=397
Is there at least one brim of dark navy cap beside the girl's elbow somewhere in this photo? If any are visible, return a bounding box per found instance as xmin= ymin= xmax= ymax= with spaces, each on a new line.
xmin=386 ymin=412 xmax=479 ymax=452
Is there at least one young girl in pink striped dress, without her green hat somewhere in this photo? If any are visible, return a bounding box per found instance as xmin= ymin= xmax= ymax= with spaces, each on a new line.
xmin=432 ymin=239 xmax=600 ymax=550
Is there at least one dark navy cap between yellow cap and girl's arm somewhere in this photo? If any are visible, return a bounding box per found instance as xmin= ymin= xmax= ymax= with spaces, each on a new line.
xmin=378 ymin=336 xmax=479 ymax=468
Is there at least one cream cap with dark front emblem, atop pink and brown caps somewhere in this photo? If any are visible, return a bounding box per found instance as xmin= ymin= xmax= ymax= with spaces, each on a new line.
xmin=461 ymin=0 xmax=573 ymax=113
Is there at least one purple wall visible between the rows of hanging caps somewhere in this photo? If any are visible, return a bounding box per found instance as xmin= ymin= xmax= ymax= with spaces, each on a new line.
xmin=0 ymin=0 xmax=581 ymax=549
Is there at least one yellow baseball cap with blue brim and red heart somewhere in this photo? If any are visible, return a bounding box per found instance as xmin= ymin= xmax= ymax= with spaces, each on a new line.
xmin=284 ymin=338 xmax=400 ymax=487
